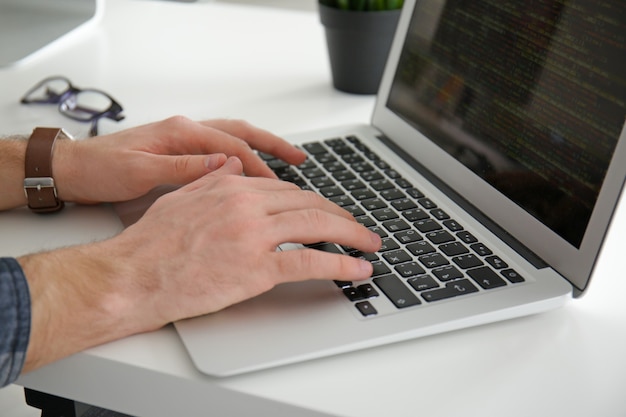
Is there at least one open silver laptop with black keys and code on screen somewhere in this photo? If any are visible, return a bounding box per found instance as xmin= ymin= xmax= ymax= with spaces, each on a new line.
xmin=123 ymin=0 xmax=626 ymax=377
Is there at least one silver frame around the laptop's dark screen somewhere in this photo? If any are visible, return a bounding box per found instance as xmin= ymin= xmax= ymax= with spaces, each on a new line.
xmin=372 ymin=0 xmax=626 ymax=293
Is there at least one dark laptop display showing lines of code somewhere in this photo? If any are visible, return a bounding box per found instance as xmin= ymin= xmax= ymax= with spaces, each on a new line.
xmin=387 ymin=0 xmax=626 ymax=248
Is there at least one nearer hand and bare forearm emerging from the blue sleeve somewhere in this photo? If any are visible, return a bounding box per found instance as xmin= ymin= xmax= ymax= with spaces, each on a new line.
xmin=19 ymin=157 xmax=381 ymax=370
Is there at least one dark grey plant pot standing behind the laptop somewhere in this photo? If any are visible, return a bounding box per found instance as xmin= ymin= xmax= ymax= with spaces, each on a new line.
xmin=318 ymin=0 xmax=404 ymax=94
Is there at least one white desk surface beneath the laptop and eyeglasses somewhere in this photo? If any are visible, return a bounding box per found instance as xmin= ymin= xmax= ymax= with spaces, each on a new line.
xmin=0 ymin=0 xmax=626 ymax=417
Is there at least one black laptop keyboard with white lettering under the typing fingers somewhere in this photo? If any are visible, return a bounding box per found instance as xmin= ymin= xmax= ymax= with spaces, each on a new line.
xmin=259 ymin=135 xmax=524 ymax=316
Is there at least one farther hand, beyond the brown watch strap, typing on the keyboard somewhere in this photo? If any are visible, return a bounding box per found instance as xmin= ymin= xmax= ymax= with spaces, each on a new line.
xmin=53 ymin=116 xmax=305 ymax=203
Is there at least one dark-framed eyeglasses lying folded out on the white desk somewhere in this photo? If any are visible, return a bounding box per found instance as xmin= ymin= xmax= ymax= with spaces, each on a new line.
xmin=20 ymin=77 xmax=124 ymax=136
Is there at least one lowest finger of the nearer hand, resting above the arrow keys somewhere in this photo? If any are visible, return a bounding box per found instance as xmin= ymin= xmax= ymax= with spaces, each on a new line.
xmin=270 ymin=249 xmax=373 ymax=282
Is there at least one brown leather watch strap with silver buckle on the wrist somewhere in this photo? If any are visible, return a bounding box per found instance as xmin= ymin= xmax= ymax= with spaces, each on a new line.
xmin=24 ymin=127 xmax=71 ymax=213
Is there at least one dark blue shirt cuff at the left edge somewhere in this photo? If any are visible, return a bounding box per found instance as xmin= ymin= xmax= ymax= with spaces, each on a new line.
xmin=0 ymin=258 xmax=31 ymax=387
